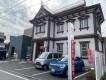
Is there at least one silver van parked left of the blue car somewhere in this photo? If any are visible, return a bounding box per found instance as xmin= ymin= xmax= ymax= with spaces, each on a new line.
xmin=35 ymin=52 xmax=62 ymax=70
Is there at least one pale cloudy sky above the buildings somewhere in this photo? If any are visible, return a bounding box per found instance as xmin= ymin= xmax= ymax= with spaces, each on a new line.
xmin=0 ymin=0 xmax=106 ymax=42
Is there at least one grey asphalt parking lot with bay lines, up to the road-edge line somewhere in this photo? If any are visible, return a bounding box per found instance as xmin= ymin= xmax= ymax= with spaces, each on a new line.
xmin=0 ymin=61 xmax=88 ymax=80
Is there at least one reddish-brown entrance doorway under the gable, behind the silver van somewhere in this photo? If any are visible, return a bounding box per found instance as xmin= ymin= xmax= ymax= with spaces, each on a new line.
xmin=36 ymin=41 xmax=44 ymax=58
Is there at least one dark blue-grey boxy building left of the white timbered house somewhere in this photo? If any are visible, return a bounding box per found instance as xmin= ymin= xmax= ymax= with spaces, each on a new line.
xmin=9 ymin=29 xmax=32 ymax=60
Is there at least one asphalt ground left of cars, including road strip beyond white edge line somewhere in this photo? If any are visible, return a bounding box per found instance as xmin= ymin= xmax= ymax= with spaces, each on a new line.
xmin=0 ymin=61 xmax=66 ymax=80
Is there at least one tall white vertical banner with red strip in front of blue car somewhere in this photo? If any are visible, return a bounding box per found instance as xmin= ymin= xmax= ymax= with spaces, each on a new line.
xmin=68 ymin=22 xmax=75 ymax=80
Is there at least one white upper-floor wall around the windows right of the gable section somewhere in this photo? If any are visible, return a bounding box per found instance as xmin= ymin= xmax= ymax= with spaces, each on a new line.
xmin=55 ymin=13 xmax=94 ymax=38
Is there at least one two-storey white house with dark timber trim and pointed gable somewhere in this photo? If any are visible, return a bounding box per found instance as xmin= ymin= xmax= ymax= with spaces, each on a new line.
xmin=30 ymin=3 xmax=104 ymax=61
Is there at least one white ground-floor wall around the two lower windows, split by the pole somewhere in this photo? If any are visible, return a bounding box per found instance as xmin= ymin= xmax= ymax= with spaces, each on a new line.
xmin=54 ymin=38 xmax=95 ymax=57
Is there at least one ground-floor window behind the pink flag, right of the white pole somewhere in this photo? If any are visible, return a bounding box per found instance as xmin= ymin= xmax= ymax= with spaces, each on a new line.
xmin=80 ymin=41 xmax=89 ymax=58
